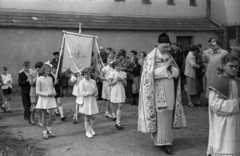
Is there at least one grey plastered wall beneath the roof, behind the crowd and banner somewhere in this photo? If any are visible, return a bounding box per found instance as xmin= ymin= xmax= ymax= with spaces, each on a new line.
xmin=0 ymin=28 xmax=218 ymax=90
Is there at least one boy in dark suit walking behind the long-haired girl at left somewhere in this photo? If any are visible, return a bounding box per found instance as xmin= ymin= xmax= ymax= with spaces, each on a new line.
xmin=18 ymin=61 xmax=31 ymax=121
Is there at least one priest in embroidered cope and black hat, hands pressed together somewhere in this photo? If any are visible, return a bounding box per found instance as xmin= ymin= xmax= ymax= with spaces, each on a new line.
xmin=138 ymin=33 xmax=186 ymax=154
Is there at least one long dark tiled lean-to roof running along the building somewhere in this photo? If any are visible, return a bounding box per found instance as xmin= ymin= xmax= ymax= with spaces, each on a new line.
xmin=0 ymin=11 xmax=220 ymax=31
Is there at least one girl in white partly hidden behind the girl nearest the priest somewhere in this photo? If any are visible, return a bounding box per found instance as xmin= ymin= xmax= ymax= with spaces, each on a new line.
xmin=100 ymin=58 xmax=116 ymax=121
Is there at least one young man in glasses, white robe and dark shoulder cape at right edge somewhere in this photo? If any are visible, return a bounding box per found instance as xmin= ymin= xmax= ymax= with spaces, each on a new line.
xmin=207 ymin=54 xmax=240 ymax=156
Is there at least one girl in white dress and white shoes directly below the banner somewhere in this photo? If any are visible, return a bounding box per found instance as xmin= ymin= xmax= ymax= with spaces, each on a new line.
xmin=79 ymin=67 xmax=99 ymax=138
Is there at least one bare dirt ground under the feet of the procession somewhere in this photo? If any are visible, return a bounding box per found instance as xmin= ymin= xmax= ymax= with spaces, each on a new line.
xmin=0 ymin=96 xmax=208 ymax=156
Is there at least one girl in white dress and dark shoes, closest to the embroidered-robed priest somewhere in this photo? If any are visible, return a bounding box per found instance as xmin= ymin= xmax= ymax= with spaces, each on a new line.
xmin=109 ymin=61 xmax=127 ymax=130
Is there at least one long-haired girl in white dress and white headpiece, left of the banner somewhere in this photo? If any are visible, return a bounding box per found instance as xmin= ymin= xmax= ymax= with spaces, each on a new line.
xmin=36 ymin=64 xmax=57 ymax=139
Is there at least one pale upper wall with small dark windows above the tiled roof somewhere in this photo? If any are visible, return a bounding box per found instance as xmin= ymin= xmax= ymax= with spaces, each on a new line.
xmin=0 ymin=0 xmax=206 ymax=17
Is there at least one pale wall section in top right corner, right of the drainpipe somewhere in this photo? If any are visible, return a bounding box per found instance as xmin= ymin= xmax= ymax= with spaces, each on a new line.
xmin=211 ymin=0 xmax=240 ymax=25
